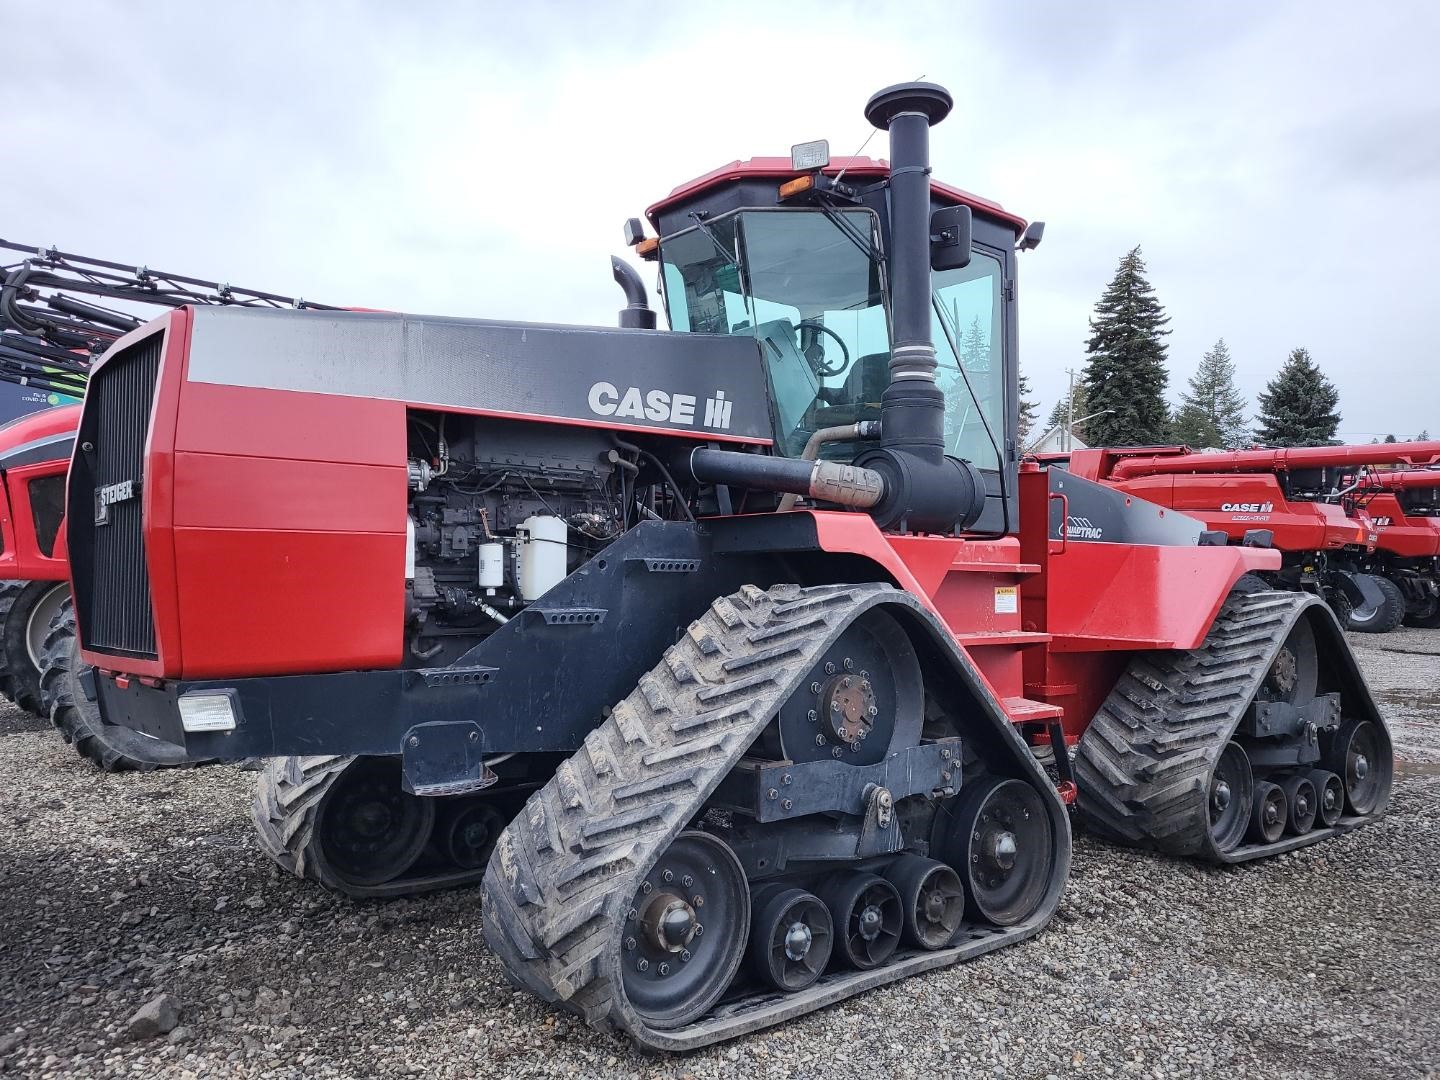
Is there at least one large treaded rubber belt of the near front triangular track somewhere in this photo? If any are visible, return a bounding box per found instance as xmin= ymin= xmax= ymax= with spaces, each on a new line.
xmin=482 ymin=585 xmax=1053 ymax=1050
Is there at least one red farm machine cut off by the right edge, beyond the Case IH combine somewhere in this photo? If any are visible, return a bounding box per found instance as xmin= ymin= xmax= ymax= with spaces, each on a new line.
xmin=1358 ymin=468 xmax=1440 ymax=629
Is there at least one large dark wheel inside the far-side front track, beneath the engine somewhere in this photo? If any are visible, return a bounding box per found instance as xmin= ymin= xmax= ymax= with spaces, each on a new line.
xmin=315 ymin=757 xmax=435 ymax=886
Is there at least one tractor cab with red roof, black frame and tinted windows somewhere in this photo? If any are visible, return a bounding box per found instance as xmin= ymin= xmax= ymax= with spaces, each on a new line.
xmin=632 ymin=158 xmax=1025 ymax=531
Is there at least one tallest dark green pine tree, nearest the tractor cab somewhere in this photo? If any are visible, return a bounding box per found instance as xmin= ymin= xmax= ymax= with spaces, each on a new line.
xmin=1084 ymin=248 xmax=1169 ymax=446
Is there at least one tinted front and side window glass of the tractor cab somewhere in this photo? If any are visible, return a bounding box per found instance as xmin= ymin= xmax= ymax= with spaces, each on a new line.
xmin=661 ymin=210 xmax=1005 ymax=468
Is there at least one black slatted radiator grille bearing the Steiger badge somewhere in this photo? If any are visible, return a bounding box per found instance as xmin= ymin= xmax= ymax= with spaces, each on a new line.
xmin=84 ymin=334 xmax=163 ymax=660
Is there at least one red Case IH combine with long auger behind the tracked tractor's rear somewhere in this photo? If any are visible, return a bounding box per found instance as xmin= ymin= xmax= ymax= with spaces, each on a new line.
xmin=1068 ymin=442 xmax=1440 ymax=634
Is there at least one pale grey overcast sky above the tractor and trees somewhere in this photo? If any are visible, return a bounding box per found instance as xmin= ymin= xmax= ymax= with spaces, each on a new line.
xmin=0 ymin=0 xmax=1440 ymax=441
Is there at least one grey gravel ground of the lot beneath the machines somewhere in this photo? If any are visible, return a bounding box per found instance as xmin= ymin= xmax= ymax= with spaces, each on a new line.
xmin=0 ymin=631 xmax=1440 ymax=1080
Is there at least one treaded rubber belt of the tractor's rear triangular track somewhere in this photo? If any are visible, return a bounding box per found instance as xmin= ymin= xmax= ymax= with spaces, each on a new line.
xmin=1074 ymin=592 xmax=1384 ymax=863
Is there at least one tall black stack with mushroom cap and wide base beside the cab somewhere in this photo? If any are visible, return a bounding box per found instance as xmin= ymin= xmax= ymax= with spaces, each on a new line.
xmin=855 ymin=82 xmax=985 ymax=533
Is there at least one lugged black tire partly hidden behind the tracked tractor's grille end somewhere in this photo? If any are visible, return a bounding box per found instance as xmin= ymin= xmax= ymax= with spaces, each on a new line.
xmin=40 ymin=598 xmax=200 ymax=772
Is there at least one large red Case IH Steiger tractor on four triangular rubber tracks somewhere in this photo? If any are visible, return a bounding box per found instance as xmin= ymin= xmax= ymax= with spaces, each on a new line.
xmin=68 ymin=84 xmax=1392 ymax=1050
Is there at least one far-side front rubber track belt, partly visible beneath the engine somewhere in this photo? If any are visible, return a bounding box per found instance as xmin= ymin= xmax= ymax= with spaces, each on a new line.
xmin=251 ymin=756 xmax=484 ymax=900
